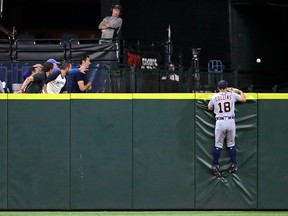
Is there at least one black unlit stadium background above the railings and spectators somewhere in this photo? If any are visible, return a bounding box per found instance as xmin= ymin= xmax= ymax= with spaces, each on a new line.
xmin=0 ymin=0 xmax=288 ymax=84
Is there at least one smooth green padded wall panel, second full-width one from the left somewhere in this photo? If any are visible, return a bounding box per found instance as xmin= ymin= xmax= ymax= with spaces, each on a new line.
xmin=71 ymin=94 xmax=132 ymax=209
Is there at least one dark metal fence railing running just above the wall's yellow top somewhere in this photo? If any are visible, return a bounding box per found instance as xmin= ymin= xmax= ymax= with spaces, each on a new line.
xmin=0 ymin=61 xmax=288 ymax=93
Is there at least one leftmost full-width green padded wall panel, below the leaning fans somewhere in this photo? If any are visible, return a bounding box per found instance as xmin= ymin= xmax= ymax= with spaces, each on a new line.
xmin=8 ymin=94 xmax=70 ymax=210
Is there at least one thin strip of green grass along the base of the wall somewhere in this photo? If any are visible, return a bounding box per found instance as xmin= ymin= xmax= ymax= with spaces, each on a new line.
xmin=0 ymin=211 xmax=288 ymax=216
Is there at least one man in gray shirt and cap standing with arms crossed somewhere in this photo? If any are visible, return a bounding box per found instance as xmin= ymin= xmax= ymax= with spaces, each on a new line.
xmin=98 ymin=4 xmax=122 ymax=44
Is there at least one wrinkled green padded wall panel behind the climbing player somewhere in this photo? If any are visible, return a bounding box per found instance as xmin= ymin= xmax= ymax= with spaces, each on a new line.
xmin=195 ymin=94 xmax=257 ymax=209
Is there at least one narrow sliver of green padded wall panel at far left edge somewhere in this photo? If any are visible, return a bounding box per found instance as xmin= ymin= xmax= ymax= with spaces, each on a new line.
xmin=0 ymin=94 xmax=7 ymax=209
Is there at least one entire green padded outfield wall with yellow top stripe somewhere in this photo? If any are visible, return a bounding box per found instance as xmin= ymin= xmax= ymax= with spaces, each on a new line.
xmin=0 ymin=93 xmax=288 ymax=210
